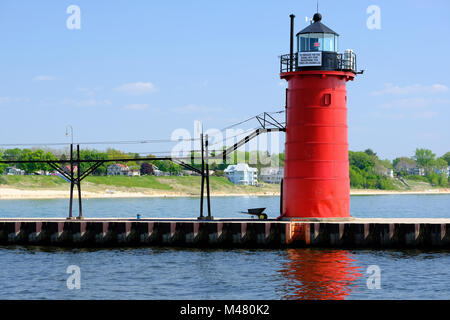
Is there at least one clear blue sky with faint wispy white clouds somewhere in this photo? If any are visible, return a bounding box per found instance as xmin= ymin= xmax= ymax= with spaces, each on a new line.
xmin=0 ymin=0 xmax=450 ymax=159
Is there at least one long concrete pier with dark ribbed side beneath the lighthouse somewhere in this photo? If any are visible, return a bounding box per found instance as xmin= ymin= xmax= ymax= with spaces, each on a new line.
xmin=0 ymin=218 xmax=450 ymax=249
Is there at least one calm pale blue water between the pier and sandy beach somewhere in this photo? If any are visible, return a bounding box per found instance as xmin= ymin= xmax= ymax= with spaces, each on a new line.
xmin=0 ymin=194 xmax=450 ymax=218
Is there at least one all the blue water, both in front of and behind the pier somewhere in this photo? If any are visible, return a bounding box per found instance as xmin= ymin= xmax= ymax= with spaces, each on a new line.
xmin=0 ymin=195 xmax=450 ymax=300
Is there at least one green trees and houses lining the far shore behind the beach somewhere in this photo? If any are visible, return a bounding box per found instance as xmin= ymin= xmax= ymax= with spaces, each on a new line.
xmin=0 ymin=148 xmax=450 ymax=189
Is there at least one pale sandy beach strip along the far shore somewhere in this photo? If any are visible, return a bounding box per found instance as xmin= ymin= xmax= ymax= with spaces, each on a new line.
xmin=0 ymin=187 xmax=450 ymax=200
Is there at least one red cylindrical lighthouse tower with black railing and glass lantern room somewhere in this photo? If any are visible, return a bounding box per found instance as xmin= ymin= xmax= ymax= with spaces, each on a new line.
xmin=280 ymin=13 xmax=357 ymax=219
